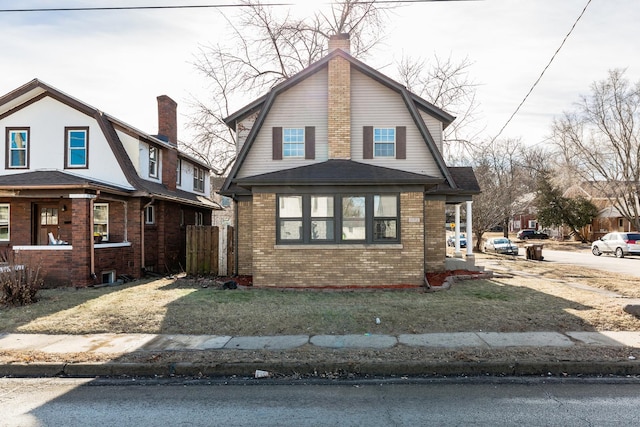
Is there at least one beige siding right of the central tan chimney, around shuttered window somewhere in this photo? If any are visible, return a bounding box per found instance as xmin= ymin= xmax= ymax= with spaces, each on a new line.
xmin=351 ymin=68 xmax=442 ymax=177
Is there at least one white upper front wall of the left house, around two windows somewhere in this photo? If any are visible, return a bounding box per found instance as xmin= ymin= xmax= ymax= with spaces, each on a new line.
xmin=0 ymin=97 xmax=131 ymax=188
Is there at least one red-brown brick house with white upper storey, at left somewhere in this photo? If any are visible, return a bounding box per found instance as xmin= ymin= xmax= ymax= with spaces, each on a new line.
xmin=0 ymin=80 xmax=219 ymax=286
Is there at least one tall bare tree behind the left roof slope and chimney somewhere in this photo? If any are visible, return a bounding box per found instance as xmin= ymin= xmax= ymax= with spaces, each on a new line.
xmin=182 ymin=0 xmax=390 ymax=175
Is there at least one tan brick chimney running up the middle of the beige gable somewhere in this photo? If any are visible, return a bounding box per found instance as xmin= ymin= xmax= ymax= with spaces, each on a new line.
xmin=327 ymin=34 xmax=351 ymax=159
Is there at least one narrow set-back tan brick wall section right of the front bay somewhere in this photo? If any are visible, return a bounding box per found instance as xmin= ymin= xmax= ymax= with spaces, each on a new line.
xmin=424 ymin=199 xmax=447 ymax=272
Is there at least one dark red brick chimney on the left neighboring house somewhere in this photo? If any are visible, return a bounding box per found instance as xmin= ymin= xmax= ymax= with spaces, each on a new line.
xmin=157 ymin=95 xmax=178 ymax=191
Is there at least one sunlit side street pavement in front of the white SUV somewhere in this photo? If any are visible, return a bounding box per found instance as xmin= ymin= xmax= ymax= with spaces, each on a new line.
xmin=536 ymin=249 xmax=640 ymax=277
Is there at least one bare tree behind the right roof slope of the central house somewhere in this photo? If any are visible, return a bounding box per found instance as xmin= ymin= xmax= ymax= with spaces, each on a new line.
xmin=397 ymin=55 xmax=481 ymax=160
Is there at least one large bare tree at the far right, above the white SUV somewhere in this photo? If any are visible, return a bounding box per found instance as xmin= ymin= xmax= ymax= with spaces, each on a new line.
xmin=553 ymin=69 xmax=640 ymax=230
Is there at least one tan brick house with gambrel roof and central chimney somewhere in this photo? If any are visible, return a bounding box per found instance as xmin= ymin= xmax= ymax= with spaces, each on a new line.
xmin=221 ymin=35 xmax=480 ymax=287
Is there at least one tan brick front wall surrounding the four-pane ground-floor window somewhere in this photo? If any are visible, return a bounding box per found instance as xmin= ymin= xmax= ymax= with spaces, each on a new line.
xmin=252 ymin=193 xmax=425 ymax=287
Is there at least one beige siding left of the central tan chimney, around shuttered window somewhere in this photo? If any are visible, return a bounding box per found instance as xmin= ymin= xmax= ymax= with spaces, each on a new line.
xmin=238 ymin=68 xmax=329 ymax=178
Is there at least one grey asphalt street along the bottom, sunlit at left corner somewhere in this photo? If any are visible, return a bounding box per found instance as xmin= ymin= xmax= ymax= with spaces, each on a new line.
xmin=0 ymin=378 xmax=640 ymax=427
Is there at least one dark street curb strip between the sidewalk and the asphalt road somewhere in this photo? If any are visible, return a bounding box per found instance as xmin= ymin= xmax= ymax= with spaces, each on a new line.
xmin=0 ymin=361 xmax=640 ymax=378
